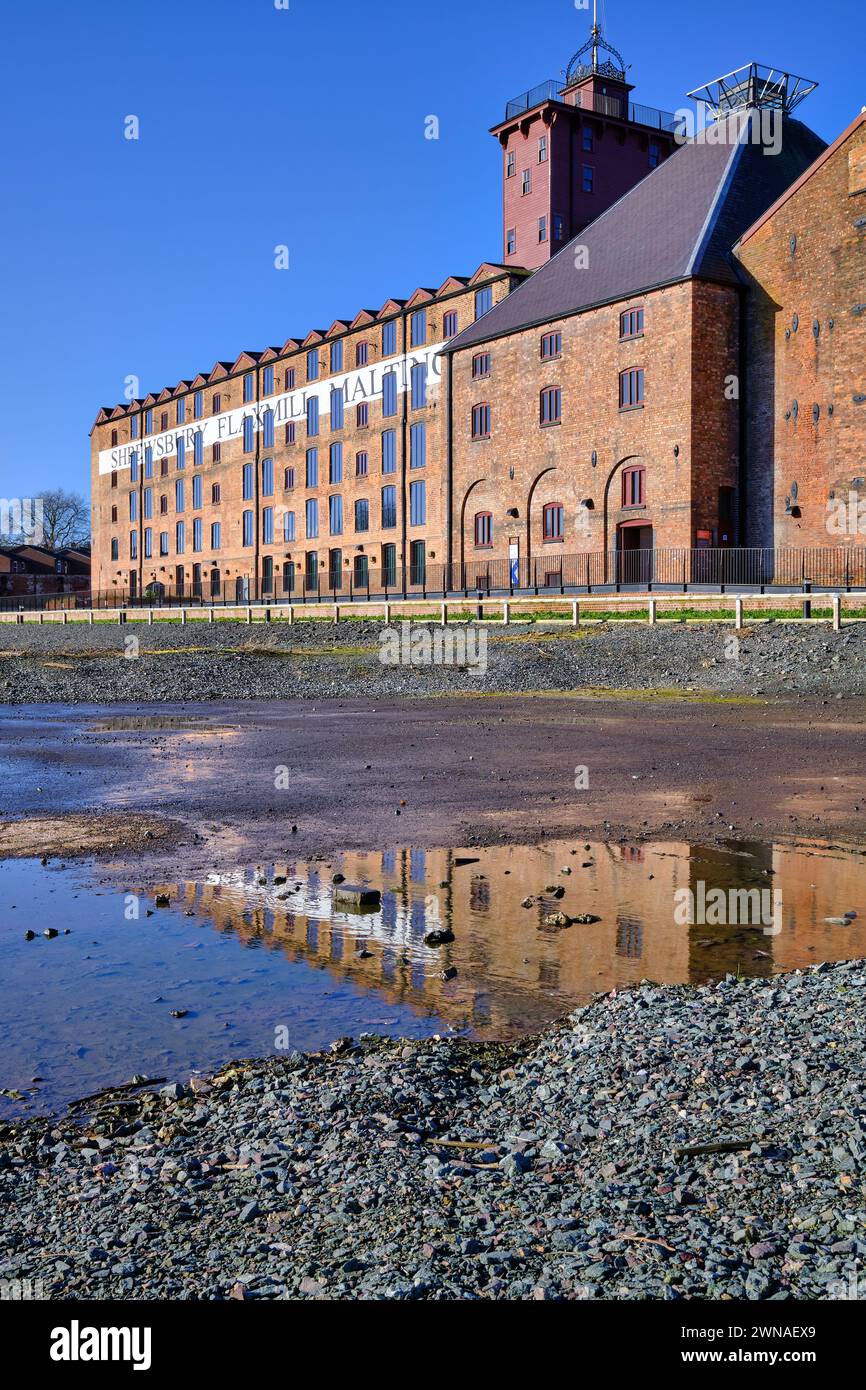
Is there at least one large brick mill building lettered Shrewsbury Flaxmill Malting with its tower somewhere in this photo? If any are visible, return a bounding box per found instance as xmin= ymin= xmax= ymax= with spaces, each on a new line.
xmin=92 ymin=16 xmax=866 ymax=599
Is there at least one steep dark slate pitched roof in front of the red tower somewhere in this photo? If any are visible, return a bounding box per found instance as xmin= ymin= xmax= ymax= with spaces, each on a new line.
xmin=443 ymin=111 xmax=824 ymax=352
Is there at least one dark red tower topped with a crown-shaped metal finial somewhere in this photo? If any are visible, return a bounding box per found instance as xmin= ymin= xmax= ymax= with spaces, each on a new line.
xmin=491 ymin=10 xmax=676 ymax=270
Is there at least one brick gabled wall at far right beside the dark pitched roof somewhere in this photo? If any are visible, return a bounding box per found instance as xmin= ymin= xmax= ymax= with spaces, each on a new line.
xmin=738 ymin=121 xmax=866 ymax=546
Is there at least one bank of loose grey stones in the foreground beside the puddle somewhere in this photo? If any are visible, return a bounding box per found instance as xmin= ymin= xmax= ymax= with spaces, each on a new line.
xmin=0 ymin=961 xmax=866 ymax=1300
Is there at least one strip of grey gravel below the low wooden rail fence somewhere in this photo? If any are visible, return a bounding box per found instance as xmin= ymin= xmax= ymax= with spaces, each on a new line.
xmin=0 ymin=623 xmax=866 ymax=705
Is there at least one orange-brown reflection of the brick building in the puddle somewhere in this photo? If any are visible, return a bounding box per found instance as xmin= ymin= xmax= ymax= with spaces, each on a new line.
xmin=152 ymin=841 xmax=866 ymax=1037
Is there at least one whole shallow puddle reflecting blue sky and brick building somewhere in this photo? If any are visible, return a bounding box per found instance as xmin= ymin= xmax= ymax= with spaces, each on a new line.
xmin=0 ymin=841 xmax=866 ymax=1115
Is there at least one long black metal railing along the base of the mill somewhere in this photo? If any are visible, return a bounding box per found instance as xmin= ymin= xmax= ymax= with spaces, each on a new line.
xmin=0 ymin=546 xmax=866 ymax=612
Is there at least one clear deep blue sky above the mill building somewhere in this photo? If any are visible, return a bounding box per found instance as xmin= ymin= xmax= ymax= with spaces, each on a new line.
xmin=0 ymin=0 xmax=866 ymax=496
